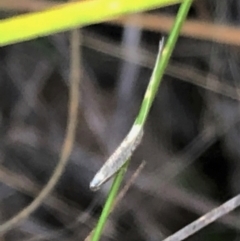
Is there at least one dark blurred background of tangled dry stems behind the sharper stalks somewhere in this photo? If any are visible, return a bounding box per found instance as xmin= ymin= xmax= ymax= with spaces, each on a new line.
xmin=0 ymin=0 xmax=240 ymax=241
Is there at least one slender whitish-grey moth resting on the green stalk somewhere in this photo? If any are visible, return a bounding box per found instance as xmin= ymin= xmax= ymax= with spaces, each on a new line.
xmin=90 ymin=124 xmax=143 ymax=191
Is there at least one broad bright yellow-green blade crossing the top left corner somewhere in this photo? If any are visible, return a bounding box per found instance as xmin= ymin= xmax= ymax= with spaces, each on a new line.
xmin=0 ymin=0 xmax=182 ymax=46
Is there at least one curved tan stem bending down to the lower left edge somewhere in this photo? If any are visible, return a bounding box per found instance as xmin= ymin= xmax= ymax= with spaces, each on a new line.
xmin=0 ymin=30 xmax=80 ymax=234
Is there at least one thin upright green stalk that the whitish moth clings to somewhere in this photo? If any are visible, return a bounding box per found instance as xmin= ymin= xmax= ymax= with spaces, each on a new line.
xmin=92 ymin=0 xmax=193 ymax=241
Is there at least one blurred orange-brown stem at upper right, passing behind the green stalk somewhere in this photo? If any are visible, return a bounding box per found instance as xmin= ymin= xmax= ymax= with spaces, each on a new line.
xmin=109 ymin=14 xmax=240 ymax=46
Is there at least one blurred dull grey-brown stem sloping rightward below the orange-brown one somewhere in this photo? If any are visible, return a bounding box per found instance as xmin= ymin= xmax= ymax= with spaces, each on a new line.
xmin=83 ymin=31 xmax=240 ymax=101
